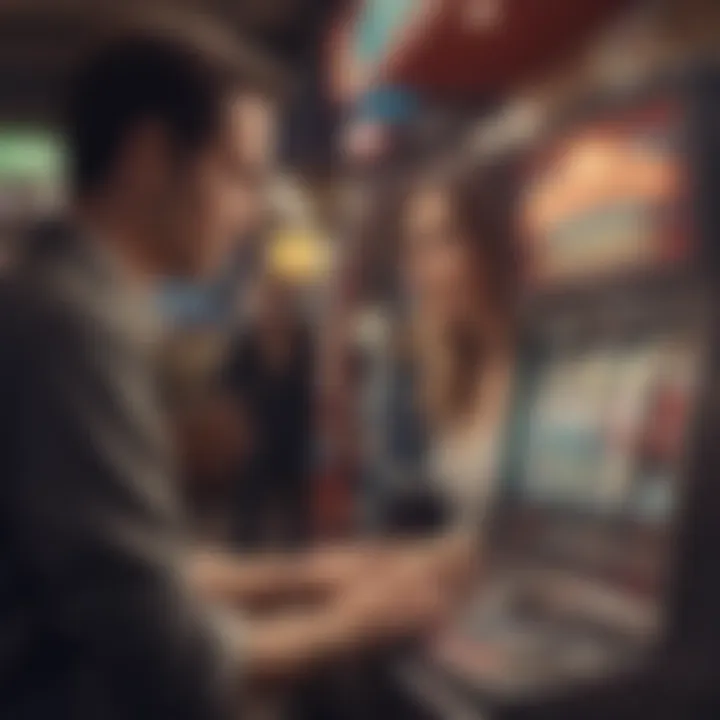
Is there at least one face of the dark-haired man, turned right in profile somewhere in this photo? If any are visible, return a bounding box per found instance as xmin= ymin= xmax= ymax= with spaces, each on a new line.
xmin=167 ymin=95 xmax=275 ymax=276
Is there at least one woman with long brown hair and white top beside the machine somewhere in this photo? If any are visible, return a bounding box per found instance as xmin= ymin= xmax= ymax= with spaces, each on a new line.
xmin=401 ymin=166 xmax=518 ymax=525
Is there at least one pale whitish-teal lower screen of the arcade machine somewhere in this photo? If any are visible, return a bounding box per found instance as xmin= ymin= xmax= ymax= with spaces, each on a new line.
xmin=520 ymin=338 xmax=697 ymax=524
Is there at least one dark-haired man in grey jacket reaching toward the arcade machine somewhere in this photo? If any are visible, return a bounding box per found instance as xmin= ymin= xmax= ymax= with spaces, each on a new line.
xmin=0 ymin=16 xmax=472 ymax=720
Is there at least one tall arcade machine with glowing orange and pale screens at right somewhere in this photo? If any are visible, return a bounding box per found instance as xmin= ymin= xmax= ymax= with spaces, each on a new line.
xmin=401 ymin=64 xmax=720 ymax=720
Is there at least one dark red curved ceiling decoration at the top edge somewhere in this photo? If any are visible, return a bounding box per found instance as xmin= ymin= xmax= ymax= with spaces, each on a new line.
xmin=380 ymin=0 xmax=636 ymax=95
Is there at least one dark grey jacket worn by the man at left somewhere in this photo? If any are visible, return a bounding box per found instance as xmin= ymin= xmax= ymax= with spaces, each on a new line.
xmin=0 ymin=222 xmax=243 ymax=720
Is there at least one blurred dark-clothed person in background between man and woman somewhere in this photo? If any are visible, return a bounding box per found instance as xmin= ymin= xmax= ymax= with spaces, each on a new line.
xmin=224 ymin=274 xmax=314 ymax=548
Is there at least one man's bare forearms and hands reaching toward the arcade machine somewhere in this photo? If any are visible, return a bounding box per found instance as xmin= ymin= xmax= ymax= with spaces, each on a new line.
xmin=211 ymin=535 xmax=484 ymax=680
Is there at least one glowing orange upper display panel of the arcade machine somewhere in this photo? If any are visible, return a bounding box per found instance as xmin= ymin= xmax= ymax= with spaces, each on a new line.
xmin=520 ymin=104 xmax=689 ymax=286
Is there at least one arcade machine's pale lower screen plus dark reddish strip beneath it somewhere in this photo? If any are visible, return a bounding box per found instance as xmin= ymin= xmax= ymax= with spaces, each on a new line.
xmin=503 ymin=332 xmax=700 ymax=597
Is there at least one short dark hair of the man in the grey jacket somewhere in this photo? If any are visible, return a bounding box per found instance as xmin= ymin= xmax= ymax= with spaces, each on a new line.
xmin=65 ymin=22 xmax=277 ymax=195
